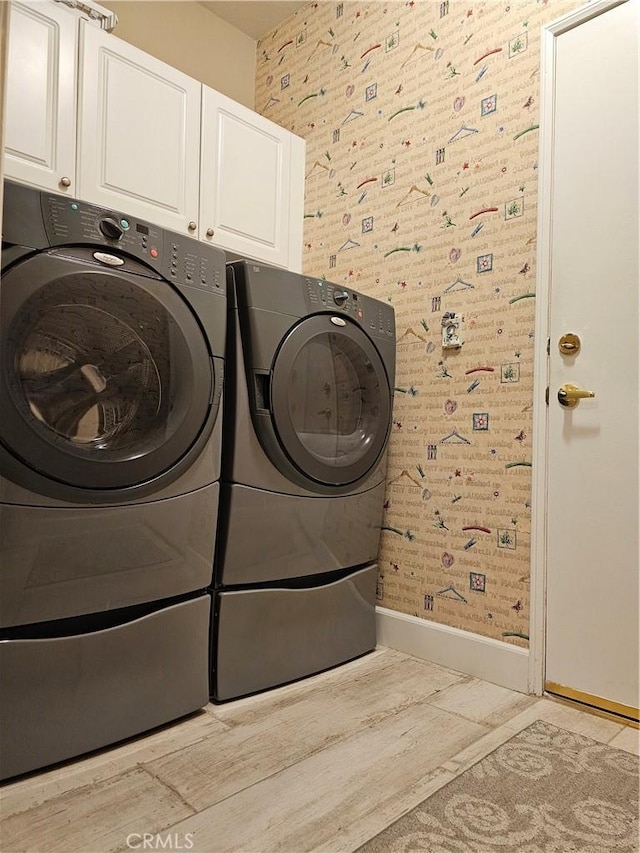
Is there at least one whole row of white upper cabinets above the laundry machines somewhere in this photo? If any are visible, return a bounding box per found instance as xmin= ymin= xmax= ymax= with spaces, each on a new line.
xmin=0 ymin=0 xmax=305 ymax=272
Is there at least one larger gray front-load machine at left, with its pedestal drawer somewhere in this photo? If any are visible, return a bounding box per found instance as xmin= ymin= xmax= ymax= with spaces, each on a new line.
xmin=0 ymin=182 xmax=227 ymax=778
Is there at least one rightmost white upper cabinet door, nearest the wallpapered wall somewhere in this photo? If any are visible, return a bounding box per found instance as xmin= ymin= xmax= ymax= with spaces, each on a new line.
xmin=200 ymin=86 xmax=304 ymax=271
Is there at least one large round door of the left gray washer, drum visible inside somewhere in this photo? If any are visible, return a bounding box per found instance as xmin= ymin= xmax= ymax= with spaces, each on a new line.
xmin=1 ymin=256 xmax=211 ymax=488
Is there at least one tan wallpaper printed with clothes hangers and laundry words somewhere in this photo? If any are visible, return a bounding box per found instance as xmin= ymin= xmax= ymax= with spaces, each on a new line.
xmin=256 ymin=0 xmax=581 ymax=647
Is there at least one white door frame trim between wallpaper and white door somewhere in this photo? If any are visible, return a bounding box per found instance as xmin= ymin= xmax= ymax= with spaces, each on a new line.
xmin=528 ymin=0 xmax=629 ymax=696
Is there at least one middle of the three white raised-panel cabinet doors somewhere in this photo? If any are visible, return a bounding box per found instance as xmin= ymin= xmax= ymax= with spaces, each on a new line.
xmin=78 ymin=23 xmax=201 ymax=236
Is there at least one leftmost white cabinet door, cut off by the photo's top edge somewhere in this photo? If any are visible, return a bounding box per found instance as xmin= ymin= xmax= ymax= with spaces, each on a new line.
xmin=4 ymin=2 xmax=78 ymax=195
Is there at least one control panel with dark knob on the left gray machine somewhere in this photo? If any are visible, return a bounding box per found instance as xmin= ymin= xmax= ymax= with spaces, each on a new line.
xmin=42 ymin=193 xmax=225 ymax=291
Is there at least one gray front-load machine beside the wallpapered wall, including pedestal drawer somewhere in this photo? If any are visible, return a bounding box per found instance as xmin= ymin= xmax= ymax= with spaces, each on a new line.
xmin=212 ymin=261 xmax=395 ymax=701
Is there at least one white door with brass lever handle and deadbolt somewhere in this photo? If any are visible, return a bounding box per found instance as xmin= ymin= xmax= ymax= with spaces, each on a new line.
xmin=545 ymin=0 xmax=640 ymax=718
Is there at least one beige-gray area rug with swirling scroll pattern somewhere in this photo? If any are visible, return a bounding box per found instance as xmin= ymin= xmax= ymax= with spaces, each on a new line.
xmin=358 ymin=722 xmax=640 ymax=853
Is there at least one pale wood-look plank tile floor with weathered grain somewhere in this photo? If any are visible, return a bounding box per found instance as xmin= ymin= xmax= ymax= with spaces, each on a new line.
xmin=0 ymin=647 xmax=638 ymax=853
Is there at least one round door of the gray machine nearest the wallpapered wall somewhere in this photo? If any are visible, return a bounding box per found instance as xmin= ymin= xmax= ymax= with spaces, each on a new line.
xmin=272 ymin=315 xmax=391 ymax=485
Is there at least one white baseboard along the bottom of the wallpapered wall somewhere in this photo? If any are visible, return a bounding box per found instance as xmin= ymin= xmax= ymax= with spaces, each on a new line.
xmin=376 ymin=607 xmax=529 ymax=693
